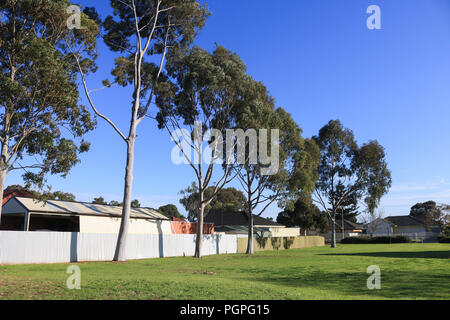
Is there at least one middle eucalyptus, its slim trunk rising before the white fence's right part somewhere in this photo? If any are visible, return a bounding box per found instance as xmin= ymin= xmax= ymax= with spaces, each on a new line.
xmin=157 ymin=46 xmax=248 ymax=258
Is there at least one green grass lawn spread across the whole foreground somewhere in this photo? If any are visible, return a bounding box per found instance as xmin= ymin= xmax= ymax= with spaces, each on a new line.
xmin=0 ymin=244 xmax=450 ymax=300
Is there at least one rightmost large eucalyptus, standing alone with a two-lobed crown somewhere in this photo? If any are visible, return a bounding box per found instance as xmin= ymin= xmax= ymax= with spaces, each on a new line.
xmin=314 ymin=120 xmax=392 ymax=248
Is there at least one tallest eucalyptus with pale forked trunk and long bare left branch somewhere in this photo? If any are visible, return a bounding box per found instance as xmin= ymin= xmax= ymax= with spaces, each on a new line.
xmin=67 ymin=0 xmax=208 ymax=261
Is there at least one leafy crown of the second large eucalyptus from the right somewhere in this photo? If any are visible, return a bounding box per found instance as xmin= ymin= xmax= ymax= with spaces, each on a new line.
xmin=235 ymin=77 xmax=320 ymax=214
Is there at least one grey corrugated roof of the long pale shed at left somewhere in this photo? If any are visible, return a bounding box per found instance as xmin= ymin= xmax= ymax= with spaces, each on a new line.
xmin=8 ymin=197 xmax=169 ymax=220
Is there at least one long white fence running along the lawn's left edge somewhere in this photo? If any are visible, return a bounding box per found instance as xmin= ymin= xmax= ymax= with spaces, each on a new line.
xmin=0 ymin=231 xmax=237 ymax=264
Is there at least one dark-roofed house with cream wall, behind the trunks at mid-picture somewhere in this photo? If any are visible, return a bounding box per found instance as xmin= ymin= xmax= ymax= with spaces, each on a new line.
xmin=204 ymin=212 xmax=300 ymax=237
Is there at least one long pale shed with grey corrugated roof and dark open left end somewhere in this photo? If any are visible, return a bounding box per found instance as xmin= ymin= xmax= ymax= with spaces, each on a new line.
xmin=0 ymin=197 xmax=173 ymax=234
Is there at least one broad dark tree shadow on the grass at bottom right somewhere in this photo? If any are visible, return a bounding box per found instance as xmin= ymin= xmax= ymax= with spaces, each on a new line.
xmin=246 ymin=269 xmax=450 ymax=300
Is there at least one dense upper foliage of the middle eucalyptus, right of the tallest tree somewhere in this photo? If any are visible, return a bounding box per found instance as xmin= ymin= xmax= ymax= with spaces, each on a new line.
xmin=156 ymin=46 xmax=246 ymax=132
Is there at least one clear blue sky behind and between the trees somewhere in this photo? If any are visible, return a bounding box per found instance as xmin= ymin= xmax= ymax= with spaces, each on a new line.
xmin=6 ymin=0 xmax=450 ymax=217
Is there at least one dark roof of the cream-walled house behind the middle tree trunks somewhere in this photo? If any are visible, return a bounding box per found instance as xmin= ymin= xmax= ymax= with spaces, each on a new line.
xmin=204 ymin=212 xmax=284 ymax=227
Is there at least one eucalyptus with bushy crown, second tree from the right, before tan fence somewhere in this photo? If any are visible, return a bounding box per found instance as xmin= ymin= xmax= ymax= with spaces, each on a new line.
xmin=230 ymin=79 xmax=319 ymax=254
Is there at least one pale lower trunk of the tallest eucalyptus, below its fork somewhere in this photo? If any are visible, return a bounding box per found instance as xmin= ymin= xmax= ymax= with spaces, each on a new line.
xmin=114 ymin=138 xmax=135 ymax=261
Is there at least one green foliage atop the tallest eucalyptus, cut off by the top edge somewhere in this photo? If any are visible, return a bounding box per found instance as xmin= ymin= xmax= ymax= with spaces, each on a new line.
xmin=102 ymin=0 xmax=209 ymax=117
